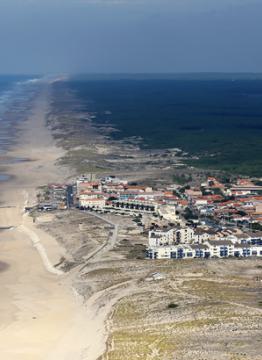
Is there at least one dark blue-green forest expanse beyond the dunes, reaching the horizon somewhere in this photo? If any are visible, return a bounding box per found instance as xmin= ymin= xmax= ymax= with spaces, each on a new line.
xmin=56 ymin=78 xmax=262 ymax=176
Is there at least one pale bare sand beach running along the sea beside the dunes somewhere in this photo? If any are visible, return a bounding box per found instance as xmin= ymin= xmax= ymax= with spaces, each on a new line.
xmin=0 ymin=86 xmax=105 ymax=360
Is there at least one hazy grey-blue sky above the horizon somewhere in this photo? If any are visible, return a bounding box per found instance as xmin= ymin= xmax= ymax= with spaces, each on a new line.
xmin=0 ymin=0 xmax=262 ymax=74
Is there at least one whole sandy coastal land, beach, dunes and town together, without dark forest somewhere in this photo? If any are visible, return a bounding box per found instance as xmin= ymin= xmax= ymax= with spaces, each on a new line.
xmin=0 ymin=81 xmax=262 ymax=360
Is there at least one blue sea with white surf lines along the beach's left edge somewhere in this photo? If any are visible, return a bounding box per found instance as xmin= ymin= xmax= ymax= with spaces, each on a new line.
xmin=0 ymin=75 xmax=38 ymax=182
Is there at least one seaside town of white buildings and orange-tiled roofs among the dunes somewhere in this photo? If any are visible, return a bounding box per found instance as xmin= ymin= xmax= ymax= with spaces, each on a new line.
xmin=33 ymin=174 xmax=262 ymax=260
